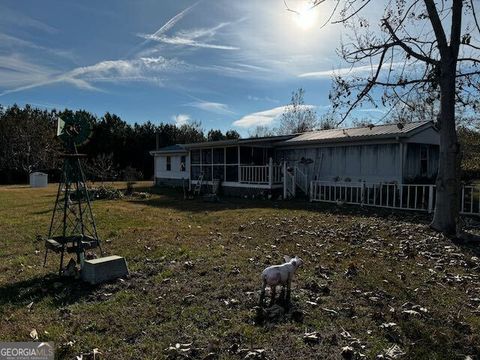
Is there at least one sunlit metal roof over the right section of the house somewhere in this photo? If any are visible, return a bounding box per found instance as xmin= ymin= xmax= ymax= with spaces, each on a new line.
xmin=283 ymin=121 xmax=433 ymax=145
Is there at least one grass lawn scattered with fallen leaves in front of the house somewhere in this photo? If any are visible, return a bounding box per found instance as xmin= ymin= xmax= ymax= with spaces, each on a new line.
xmin=0 ymin=184 xmax=480 ymax=359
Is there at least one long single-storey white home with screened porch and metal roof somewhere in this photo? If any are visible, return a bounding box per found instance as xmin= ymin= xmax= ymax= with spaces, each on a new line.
xmin=151 ymin=121 xmax=439 ymax=196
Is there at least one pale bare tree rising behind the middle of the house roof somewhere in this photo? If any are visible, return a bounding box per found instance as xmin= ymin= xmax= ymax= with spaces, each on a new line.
xmin=278 ymin=88 xmax=318 ymax=135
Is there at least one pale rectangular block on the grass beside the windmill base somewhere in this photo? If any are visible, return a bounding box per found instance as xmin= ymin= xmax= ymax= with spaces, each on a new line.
xmin=82 ymin=255 xmax=128 ymax=285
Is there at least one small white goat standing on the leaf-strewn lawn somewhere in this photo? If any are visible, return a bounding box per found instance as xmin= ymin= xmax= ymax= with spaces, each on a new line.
xmin=260 ymin=256 xmax=303 ymax=306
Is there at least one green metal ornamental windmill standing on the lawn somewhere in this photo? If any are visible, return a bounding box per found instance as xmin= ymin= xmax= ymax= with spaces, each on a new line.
xmin=44 ymin=114 xmax=102 ymax=274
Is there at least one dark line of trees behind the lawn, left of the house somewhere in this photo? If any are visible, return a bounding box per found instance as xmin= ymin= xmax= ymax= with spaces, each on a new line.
xmin=0 ymin=105 xmax=240 ymax=184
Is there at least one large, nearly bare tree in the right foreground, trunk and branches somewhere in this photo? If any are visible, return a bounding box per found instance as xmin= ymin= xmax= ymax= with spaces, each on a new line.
xmin=287 ymin=0 xmax=480 ymax=235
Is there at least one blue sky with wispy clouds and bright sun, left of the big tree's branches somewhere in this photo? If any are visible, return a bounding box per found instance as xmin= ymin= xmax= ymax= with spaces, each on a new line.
xmin=0 ymin=0 xmax=388 ymax=136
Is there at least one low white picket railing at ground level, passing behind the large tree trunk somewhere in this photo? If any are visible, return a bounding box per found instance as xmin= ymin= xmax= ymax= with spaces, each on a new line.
xmin=310 ymin=181 xmax=480 ymax=215
